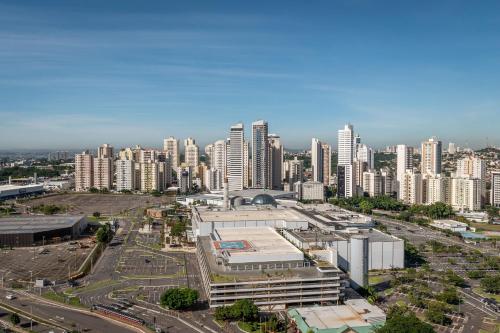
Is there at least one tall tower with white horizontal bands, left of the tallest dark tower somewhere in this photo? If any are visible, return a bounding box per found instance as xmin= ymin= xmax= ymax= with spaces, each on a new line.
xmin=227 ymin=123 xmax=245 ymax=191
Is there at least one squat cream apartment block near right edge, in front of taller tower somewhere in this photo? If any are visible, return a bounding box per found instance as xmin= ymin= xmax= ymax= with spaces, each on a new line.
xmin=451 ymin=178 xmax=482 ymax=211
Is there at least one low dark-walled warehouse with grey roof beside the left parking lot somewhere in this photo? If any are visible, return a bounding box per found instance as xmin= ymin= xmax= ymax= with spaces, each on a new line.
xmin=0 ymin=216 xmax=87 ymax=247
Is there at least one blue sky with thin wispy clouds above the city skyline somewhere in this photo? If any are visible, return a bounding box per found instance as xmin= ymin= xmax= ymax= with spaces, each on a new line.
xmin=0 ymin=0 xmax=500 ymax=149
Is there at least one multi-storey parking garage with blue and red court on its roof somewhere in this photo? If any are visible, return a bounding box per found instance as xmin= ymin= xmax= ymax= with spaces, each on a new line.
xmin=197 ymin=227 xmax=344 ymax=311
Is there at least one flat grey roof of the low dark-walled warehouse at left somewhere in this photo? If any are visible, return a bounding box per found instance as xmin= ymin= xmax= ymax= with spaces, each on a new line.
xmin=0 ymin=215 xmax=84 ymax=234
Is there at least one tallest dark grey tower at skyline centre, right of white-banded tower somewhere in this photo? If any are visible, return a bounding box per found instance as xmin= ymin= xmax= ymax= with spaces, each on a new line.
xmin=252 ymin=120 xmax=269 ymax=188
